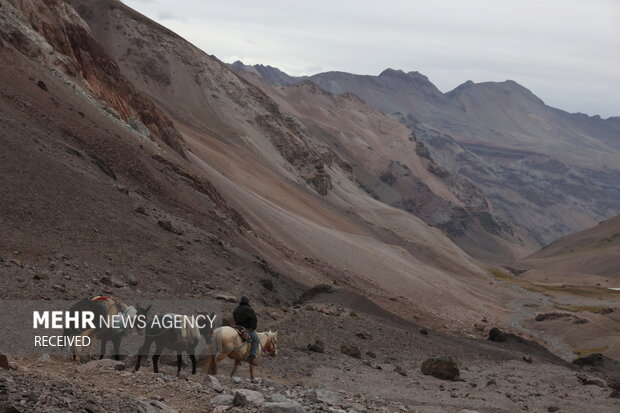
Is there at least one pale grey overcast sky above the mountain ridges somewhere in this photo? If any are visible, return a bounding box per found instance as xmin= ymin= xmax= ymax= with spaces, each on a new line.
xmin=124 ymin=0 xmax=620 ymax=117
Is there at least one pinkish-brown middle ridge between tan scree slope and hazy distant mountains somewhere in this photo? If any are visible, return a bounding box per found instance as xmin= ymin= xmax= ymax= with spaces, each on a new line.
xmin=232 ymin=70 xmax=525 ymax=262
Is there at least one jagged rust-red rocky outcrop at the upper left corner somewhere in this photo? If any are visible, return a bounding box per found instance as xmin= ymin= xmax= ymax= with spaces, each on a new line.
xmin=0 ymin=0 xmax=185 ymax=156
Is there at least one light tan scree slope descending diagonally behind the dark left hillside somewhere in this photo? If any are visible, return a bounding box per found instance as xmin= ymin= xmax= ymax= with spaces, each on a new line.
xmin=65 ymin=0 xmax=528 ymax=324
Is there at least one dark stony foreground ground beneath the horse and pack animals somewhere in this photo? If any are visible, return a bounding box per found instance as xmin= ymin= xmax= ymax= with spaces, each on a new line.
xmin=2 ymin=300 xmax=619 ymax=413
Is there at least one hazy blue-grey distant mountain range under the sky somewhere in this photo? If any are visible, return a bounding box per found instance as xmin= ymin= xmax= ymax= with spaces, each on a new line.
xmin=235 ymin=64 xmax=620 ymax=246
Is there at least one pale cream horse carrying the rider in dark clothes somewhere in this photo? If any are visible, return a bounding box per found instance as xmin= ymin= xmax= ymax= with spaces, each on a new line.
xmin=201 ymin=326 xmax=278 ymax=380
